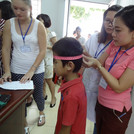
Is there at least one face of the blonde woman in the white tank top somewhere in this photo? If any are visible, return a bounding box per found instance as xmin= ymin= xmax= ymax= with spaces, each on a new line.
xmin=12 ymin=0 xmax=32 ymax=20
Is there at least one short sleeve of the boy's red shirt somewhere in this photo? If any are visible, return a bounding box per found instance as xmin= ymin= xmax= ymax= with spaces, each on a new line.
xmin=62 ymin=96 xmax=78 ymax=126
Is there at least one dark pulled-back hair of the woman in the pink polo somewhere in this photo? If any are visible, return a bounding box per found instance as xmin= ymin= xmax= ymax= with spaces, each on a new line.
xmin=114 ymin=5 xmax=134 ymax=31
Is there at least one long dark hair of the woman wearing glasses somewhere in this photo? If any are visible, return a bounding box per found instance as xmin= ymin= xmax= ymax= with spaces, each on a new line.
xmin=98 ymin=5 xmax=122 ymax=43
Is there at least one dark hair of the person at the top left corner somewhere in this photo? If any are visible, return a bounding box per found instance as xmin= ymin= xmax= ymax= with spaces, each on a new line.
xmin=0 ymin=1 xmax=15 ymax=20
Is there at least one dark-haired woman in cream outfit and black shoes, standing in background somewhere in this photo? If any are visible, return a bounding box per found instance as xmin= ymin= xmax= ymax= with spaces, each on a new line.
xmin=37 ymin=14 xmax=57 ymax=108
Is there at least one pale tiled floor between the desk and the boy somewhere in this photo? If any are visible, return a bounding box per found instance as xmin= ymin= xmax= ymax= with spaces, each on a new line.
xmin=27 ymin=85 xmax=93 ymax=134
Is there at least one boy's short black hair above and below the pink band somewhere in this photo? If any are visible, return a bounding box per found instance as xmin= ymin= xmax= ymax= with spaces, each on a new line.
xmin=52 ymin=37 xmax=83 ymax=72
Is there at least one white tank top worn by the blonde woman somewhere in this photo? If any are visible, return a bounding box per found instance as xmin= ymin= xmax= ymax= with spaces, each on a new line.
xmin=10 ymin=18 xmax=44 ymax=74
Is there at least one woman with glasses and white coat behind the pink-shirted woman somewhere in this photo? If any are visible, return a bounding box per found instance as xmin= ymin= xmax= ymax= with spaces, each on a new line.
xmin=83 ymin=5 xmax=121 ymax=134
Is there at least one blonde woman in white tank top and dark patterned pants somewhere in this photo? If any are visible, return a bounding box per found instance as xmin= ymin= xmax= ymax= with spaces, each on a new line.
xmin=2 ymin=0 xmax=46 ymax=134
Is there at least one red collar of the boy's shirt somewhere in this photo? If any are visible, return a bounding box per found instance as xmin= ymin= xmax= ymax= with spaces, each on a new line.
xmin=58 ymin=74 xmax=82 ymax=93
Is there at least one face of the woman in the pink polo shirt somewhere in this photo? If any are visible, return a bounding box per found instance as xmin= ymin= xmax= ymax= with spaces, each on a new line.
xmin=112 ymin=17 xmax=134 ymax=48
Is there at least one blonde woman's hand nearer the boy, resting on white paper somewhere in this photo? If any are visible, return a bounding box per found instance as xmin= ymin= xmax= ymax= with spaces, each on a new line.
xmin=20 ymin=71 xmax=34 ymax=83
